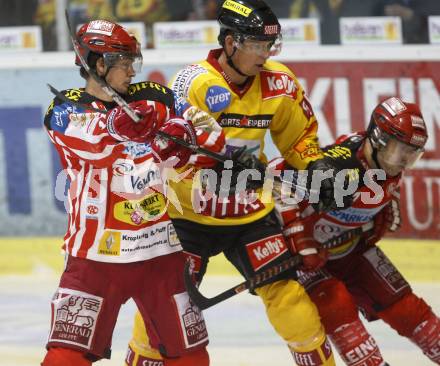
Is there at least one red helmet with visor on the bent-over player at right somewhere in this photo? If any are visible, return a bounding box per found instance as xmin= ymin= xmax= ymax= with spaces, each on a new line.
xmin=367 ymin=97 xmax=428 ymax=169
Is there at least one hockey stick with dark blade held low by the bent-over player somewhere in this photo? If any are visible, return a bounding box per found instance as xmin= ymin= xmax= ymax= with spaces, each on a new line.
xmin=184 ymin=221 xmax=374 ymax=310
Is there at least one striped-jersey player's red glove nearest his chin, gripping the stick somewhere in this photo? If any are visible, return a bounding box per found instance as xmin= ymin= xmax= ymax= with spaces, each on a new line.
xmin=105 ymin=100 xmax=157 ymax=142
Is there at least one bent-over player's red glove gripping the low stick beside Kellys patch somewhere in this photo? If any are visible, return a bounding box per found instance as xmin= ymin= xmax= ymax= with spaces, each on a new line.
xmin=283 ymin=220 xmax=329 ymax=271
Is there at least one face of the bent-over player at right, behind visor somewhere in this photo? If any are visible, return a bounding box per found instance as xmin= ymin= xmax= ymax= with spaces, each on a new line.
xmin=377 ymin=138 xmax=424 ymax=177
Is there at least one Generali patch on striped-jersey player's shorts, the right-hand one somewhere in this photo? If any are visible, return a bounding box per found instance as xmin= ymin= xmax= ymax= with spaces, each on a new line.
xmin=174 ymin=292 xmax=208 ymax=348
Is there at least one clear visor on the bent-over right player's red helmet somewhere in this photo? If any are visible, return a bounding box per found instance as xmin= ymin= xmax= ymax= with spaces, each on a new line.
xmin=380 ymin=138 xmax=425 ymax=170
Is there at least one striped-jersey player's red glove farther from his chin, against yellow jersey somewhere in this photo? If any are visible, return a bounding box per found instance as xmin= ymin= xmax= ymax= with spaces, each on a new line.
xmin=151 ymin=118 xmax=197 ymax=168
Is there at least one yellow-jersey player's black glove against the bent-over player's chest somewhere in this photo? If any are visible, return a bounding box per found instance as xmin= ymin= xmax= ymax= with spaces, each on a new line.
xmin=307 ymin=158 xmax=353 ymax=212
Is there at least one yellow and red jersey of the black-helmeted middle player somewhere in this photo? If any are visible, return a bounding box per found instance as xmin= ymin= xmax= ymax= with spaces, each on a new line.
xmin=169 ymin=49 xmax=322 ymax=225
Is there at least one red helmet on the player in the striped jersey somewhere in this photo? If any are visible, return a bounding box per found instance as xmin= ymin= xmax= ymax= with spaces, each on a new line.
xmin=75 ymin=20 xmax=142 ymax=73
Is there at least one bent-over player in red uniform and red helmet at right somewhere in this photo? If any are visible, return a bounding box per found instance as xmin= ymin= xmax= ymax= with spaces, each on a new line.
xmin=278 ymin=97 xmax=440 ymax=366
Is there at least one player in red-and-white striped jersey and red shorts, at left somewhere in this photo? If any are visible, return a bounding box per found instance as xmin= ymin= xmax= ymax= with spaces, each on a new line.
xmin=42 ymin=20 xmax=224 ymax=366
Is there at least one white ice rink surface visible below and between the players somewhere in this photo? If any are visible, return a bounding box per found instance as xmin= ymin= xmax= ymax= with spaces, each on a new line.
xmin=0 ymin=268 xmax=440 ymax=366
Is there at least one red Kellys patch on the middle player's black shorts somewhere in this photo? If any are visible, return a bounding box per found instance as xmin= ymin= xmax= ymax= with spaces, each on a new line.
xmin=246 ymin=234 xmax=287 ymax=271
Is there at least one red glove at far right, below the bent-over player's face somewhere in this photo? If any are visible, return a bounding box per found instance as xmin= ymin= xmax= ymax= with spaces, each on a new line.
xmin=364 ymin=199 xmax=402 ymax=245
